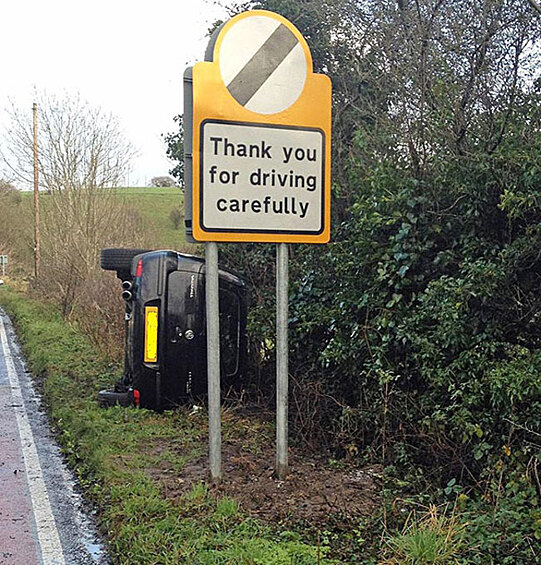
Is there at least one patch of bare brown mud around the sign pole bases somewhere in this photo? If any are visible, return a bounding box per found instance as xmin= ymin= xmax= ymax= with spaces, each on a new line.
xmin=147 ymin=440 xmax=382 ymax=527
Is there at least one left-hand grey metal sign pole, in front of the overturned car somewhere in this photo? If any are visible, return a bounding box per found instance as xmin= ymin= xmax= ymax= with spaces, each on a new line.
xmin=205 ymin=241 xmax=222 ymax=483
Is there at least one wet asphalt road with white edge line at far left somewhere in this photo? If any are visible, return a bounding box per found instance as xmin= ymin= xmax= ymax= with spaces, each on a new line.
xmin=0 ymin=309 xmax=109 ymax=565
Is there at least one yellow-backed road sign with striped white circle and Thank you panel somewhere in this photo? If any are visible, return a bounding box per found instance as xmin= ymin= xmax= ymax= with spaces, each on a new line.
xmin=187 ymin=10 xmax=331 ymax=243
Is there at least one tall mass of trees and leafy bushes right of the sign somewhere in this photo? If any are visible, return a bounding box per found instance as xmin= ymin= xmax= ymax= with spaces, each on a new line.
xmin=209 ymin=0 xmax=541 ymax=458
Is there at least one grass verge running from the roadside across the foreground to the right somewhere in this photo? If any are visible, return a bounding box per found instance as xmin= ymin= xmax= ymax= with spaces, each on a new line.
xmin=0 ymin=286 xmax=541 ymax=565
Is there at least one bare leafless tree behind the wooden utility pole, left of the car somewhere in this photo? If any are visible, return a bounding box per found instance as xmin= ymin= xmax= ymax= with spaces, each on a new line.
xmin=2 ymin=91 xmax=142 ymax=316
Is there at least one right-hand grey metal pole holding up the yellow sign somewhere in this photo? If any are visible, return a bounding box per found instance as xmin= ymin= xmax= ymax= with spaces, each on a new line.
xmin=276 ymin=243 xmax=289 ymax=479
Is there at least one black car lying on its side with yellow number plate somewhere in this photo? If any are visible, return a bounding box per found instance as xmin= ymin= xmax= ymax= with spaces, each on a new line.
xmin=99 ymin=248 xmax=247 ymax=411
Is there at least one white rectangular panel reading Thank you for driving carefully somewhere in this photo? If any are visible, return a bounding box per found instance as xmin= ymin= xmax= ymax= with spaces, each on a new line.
xmin=199 ymin=120 xmax=325 ymax=235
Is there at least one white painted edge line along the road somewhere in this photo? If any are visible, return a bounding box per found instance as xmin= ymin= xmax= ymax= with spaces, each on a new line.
xmin=0 ymin=318 xmax=66 ymax=565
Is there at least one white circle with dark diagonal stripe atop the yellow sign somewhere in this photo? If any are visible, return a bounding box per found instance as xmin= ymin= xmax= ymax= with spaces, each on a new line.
xmin=218 ymin=15 xmax=308 ymax=114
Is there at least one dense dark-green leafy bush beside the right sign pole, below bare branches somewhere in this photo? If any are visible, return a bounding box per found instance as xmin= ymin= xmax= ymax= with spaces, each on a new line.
xmin=219 ymin=87 xmax=541 ymax=490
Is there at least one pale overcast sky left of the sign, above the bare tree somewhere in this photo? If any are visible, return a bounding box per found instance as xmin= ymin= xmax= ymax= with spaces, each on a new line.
xmin=0 ymin=0 xmax=231 ymax=186
